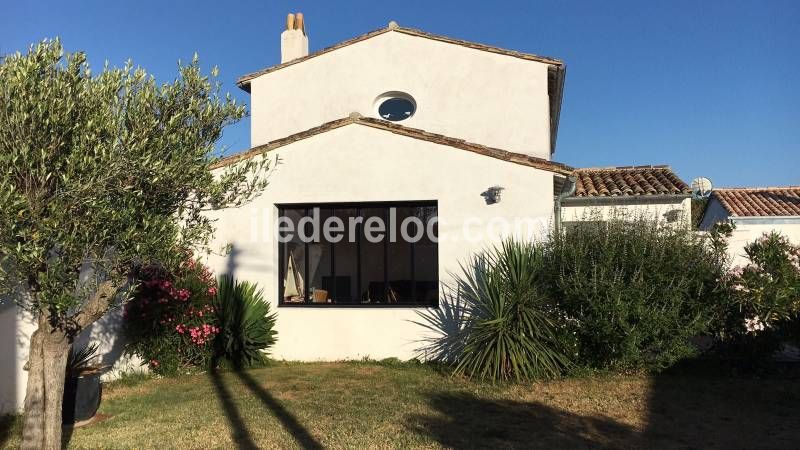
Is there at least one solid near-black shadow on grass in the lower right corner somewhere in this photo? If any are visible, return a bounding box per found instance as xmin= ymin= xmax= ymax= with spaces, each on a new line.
xmin=642 ymin=359 xmax=800 ymax=449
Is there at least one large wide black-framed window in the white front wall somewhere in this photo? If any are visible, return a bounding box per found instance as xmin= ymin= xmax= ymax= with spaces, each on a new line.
xmin=277 ymin=201 xmax=439 ymax=307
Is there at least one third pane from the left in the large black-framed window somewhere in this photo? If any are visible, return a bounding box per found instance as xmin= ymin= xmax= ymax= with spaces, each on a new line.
xmin=324 ymin=208 xmax=358 ymax=303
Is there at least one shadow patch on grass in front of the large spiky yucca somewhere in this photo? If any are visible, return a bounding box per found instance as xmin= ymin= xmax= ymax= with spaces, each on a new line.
xmin=406 ymin=393 xmax=638 ymax=448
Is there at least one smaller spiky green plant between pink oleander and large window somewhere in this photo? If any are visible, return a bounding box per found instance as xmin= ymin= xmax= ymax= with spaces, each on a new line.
xmin=213 ymin=276 xmax=277 ymax=369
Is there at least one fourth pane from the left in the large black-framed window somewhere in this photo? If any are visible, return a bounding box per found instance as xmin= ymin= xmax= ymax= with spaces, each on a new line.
xmin=360 ymin=208 xmax=386 ymax=303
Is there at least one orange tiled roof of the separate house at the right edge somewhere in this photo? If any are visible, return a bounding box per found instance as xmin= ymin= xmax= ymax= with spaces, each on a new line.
xmin=711 ymin=186 xmax=800 ymax=217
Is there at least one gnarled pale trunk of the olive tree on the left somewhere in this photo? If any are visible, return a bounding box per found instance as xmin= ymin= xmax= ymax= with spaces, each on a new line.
xmin=21 ymin=319 xmax=70 ymax=450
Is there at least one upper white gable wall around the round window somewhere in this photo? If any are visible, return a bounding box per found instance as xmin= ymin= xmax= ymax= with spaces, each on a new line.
xmin=250 ymin=32 xmax=550 ymax=159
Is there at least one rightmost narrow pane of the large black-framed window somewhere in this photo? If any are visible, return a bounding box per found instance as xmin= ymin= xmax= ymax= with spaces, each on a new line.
xmin=414 ymin=206 xmax=439 ymax=305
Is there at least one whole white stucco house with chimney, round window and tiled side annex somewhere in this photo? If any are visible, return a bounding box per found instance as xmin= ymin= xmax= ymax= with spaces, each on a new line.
xmin=0 ymin=18 xmax=700 ymax=411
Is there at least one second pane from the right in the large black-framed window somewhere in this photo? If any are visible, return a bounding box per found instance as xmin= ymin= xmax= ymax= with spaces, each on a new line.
xmin=387 ymin=206 xmax=415 ymax=303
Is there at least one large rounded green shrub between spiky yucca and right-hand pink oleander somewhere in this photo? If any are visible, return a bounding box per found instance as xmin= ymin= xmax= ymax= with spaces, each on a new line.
xmin=546 ymin=218 xmax=726 ymax=370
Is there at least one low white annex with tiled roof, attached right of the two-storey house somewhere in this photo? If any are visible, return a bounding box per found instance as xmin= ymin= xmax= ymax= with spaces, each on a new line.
xmin=556 ymin=166 xmax=692 ymax=227
